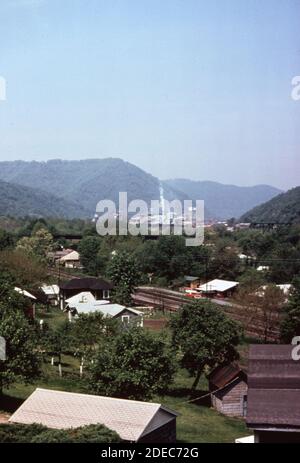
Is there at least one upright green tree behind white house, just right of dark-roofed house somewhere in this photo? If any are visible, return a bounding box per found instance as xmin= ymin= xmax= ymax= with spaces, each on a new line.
xmin=107 ymin=251 xmax=140 ymax=305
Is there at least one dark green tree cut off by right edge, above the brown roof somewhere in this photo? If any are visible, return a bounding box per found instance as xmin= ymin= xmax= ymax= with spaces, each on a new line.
xmin=280 ymin=276 xmax=300 ymax=343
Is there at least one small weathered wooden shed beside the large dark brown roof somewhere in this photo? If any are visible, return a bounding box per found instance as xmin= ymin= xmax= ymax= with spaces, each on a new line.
xmin=208 ymin=363 xmax=248 ymax=417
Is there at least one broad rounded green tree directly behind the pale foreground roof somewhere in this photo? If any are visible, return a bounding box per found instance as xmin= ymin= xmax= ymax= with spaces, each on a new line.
xmin=88 ymin=328 xmax=175 ymax=400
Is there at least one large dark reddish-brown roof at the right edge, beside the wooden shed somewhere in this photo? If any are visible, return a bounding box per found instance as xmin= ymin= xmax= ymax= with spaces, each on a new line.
xmin=247 ymin=345 xmax=300 ymax=428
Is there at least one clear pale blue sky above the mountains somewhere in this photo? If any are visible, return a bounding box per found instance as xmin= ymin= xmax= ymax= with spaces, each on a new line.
xmin=0 ymin=0 xmax=300 ymax=189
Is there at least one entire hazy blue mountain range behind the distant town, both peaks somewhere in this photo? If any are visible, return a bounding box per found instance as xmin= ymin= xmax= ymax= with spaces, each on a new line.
xmin=0 ymin=157 xmax=281 ymax=219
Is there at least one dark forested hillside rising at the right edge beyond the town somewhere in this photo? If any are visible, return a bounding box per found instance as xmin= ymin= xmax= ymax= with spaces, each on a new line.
xmin=241 ymin=186 xmax=300 ymax=223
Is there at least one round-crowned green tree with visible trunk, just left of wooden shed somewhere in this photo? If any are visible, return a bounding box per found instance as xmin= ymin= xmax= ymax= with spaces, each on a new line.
xmin=170 ymin=301 xmax=241 ymax=389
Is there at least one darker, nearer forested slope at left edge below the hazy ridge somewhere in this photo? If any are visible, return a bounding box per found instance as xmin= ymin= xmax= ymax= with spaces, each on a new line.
xmin=0 ymin=180 xmax=88 ymax=219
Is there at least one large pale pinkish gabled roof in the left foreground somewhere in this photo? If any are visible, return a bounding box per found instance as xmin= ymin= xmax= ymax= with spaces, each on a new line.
xmin=9 ymin=388 xmax=177 ymax=442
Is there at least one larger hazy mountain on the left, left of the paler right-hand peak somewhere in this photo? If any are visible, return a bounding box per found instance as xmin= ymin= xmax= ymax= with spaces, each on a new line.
xmin=0 ymin=158 xmax=186 ymax=216
